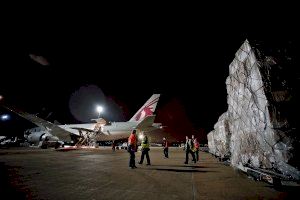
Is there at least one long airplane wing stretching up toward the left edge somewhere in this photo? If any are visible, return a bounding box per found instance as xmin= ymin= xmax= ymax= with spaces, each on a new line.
xmin=3 ymin=106 xmax=73 ymax=142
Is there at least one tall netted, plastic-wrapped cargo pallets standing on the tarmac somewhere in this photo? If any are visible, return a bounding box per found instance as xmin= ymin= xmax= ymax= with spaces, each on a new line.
xmin=208 ymin=40 xmax=300 ymax=180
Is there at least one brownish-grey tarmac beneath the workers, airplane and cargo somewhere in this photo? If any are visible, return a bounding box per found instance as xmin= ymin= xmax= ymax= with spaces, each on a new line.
xmin=0 ymin=147 xmax=300 ymax=200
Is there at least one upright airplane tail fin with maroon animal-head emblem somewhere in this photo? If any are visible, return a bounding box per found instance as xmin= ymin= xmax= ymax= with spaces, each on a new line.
xmin=129 ymin=94 xmax=160 ymax=122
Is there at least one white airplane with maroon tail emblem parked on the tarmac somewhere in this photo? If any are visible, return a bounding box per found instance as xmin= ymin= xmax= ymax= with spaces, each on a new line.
xmin=5 ymin=94 xmax=163 ymax=147
